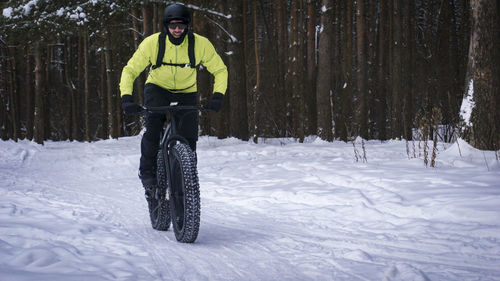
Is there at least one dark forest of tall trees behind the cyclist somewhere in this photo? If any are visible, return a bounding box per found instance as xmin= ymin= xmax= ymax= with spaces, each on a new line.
xmin=0 ymin=0 xmax=500 ymax=150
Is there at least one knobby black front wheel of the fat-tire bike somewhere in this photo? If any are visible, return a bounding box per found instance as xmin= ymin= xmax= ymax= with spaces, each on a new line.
xmin=169 ymin=143 xmax=200 ymax=243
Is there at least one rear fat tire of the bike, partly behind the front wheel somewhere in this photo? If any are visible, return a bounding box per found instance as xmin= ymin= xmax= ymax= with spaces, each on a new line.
xmin=148 ymin=150 xmax=171 ymax=231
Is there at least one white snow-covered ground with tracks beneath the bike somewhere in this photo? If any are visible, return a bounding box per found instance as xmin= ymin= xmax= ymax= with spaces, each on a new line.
xmin=0 ymin=137 xmax=500 ymax=281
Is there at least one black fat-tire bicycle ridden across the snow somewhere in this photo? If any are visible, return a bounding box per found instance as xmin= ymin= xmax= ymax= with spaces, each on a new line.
xmin=144 ymin=101 xmax=210 ymax=243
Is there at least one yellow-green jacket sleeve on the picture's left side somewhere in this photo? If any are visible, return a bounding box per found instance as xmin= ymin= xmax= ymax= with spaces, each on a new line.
xmin=120 ymin=36 xmax=154 ymax=96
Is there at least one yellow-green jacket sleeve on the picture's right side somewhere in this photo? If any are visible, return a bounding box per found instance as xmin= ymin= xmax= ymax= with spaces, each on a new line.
xmin=201 ymin=38 xmax=228 ymax=94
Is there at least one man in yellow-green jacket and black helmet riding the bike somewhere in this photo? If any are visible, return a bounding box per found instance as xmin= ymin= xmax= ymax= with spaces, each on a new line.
xmin=120 ymin=4 xmax=228 ymax=192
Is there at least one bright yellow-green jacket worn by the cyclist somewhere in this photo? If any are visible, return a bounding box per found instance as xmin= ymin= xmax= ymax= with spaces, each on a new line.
xmin=120 ymin=33 xmax=227 ymax=96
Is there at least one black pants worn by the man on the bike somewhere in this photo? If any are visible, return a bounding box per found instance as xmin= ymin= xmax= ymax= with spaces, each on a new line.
xmin=139 ymin=83 xmax=198 ymax=175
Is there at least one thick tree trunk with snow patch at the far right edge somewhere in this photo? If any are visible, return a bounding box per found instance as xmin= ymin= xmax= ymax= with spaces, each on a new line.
xmin=462 ymin=0 xmax=500 ymax=150
